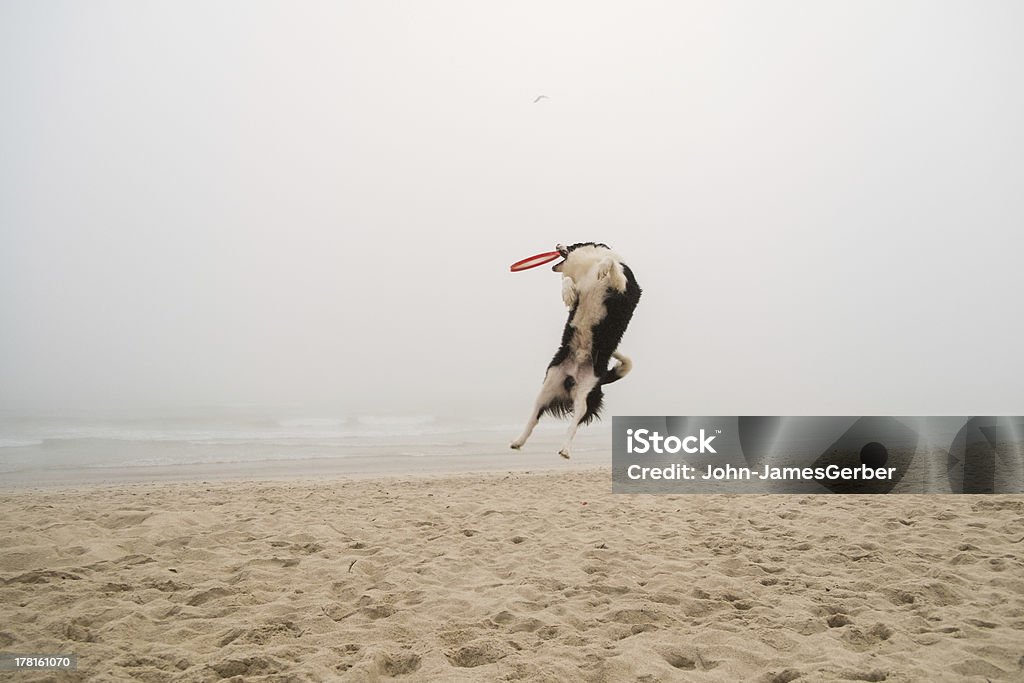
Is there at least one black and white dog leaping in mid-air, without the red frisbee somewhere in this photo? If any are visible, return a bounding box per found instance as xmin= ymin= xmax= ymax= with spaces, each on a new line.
xmin=511 ymin=242 xmax=640 ymax=458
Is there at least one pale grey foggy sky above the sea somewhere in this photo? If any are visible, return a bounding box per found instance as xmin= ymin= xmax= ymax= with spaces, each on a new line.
xmin=0 ymin=0 xmax=1024 ymax=418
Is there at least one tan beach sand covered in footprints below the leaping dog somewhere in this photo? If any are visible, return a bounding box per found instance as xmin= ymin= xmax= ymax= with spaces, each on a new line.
xmin=0 ymin=465 xmax=1024 ymax=683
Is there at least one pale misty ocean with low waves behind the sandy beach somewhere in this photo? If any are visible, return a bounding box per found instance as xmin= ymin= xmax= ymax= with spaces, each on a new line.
xmin=0 ymin=410 xmax=611 ymax=486
